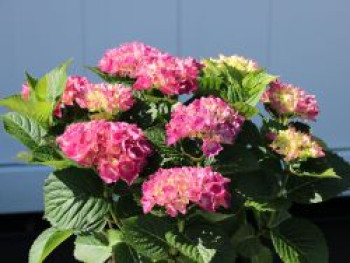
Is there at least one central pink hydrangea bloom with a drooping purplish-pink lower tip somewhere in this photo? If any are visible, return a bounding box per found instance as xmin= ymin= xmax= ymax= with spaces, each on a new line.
xmin=166 ymin=96 xmax=245 ymax=157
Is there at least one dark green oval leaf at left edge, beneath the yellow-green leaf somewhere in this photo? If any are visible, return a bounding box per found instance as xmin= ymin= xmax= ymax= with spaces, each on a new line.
xmin=3 ymin=112 xmax=47 ymax=150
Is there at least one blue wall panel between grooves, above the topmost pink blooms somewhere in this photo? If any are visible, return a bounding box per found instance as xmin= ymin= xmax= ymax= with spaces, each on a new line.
xmin=84 ymin=0 xmax=177 ymax=77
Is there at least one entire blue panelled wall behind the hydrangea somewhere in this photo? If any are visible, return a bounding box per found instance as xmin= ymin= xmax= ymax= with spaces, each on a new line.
xmin=0 ymin=0 xmax=350 ymax=213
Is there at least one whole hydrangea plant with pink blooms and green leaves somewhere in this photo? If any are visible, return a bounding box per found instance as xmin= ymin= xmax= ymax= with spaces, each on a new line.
xmin=0 ymin=42 xmax=350 ymax=263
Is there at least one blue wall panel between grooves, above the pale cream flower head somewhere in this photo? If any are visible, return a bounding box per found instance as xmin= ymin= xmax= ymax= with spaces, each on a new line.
xmin=180 ymin=0 xmax=269 ymax=65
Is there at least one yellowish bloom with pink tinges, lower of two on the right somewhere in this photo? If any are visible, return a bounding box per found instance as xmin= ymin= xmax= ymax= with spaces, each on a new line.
xmin=269 ymin=127 xmax=325 ymax=161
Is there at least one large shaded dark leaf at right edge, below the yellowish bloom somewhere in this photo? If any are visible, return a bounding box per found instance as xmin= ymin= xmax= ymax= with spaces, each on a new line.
xmin=287 ymin=152 xmax=350 ymax=203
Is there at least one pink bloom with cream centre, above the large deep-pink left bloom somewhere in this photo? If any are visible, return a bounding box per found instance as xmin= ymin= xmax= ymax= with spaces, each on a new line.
xmin=57 ymin=76 xmax=134 ymax=117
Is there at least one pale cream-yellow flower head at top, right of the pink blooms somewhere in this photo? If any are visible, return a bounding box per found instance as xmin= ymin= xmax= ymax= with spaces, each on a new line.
xmin=204 ymin=55 xmax=259 ymax=72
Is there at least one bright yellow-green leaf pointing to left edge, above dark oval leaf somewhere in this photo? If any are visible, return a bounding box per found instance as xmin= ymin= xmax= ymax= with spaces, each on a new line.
xmin=0 ymin=95 xmax=53 ymax=127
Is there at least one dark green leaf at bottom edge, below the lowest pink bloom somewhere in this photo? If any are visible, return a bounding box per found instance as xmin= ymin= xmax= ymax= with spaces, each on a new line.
xmin=122 ymin=215 xmax=176 ymax=260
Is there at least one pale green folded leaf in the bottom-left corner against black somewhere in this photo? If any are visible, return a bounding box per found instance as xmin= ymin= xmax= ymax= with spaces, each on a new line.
xmin=29 ymin=228 xmax=72 ymax=263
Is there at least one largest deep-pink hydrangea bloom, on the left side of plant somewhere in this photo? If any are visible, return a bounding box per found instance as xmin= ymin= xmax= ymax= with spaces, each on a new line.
xmin=57 ymin=120 xmax=152 ymax=184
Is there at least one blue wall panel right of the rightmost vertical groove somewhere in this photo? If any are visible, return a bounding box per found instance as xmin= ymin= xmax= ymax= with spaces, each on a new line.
xmin=270 ymin=0 xmax=350 ymax=147
